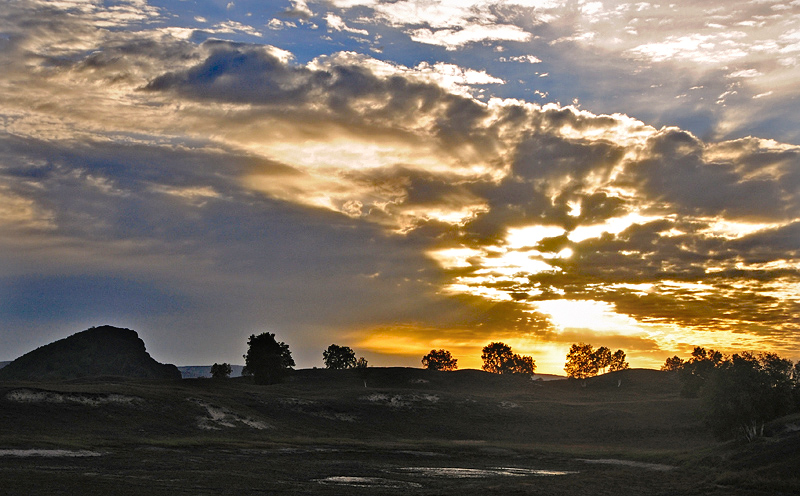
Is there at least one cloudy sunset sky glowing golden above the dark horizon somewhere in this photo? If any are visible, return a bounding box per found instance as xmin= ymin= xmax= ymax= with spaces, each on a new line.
xmin=0 ymin=0 xmax=800 ymax=374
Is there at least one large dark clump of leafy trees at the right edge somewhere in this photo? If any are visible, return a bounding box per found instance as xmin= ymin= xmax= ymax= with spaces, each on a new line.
xmin=662 ymin=346 xmax=800 ymax=441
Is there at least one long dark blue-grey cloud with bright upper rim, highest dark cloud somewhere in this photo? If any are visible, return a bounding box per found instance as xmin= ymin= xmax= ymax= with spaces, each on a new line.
xmin=144 ymin=41 xmax=496 ymax=161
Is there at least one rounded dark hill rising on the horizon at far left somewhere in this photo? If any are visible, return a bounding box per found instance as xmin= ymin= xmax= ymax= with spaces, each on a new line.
xmin=0 ymin=325 xmax=181 ymax=381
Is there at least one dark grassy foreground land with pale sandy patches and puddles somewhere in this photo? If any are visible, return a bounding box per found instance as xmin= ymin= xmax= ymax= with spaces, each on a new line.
xmin=0 ymin=368 xmax=800 ymax=496
